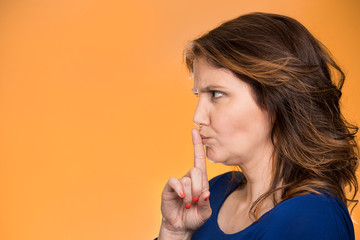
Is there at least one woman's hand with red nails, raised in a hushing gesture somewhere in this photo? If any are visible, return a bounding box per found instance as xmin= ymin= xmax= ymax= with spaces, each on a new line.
xmin=159 ymin=129 xmax=212 ymax=239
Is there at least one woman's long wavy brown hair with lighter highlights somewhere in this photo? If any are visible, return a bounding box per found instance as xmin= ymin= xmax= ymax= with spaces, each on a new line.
xmin=184 ymin=12 xmax=359 ymax=220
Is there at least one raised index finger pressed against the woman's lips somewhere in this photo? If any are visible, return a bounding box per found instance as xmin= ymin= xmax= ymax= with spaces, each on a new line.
xmin=191 ymin=128 xmax=208 ymax=182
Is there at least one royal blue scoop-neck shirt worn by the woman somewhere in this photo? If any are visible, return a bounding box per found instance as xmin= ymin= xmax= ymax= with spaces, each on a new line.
xmin=192 ymin=172 xmax=355 ymax=240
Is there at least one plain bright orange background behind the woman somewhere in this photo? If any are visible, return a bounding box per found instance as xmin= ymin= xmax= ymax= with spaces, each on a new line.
xmin=0 ymin=0 xmax=360 ymax=240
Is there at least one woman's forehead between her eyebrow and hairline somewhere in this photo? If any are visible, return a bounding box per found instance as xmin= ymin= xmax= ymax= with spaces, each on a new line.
xmin=193 ymin=57 xmax=241 ymax=89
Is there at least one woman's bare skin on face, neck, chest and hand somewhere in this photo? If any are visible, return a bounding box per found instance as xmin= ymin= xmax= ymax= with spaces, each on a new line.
xmin=159 ymin=57 xmax=273 ymax=240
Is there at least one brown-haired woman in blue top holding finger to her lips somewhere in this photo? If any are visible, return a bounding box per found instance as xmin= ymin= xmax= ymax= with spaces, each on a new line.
xmin=158 ymin=13 xmax=358 ymax=240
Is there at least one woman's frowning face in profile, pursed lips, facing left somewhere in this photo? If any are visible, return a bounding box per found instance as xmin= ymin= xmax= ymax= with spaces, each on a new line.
xmin=193 ymin=57 xmax=273 ymax=166
